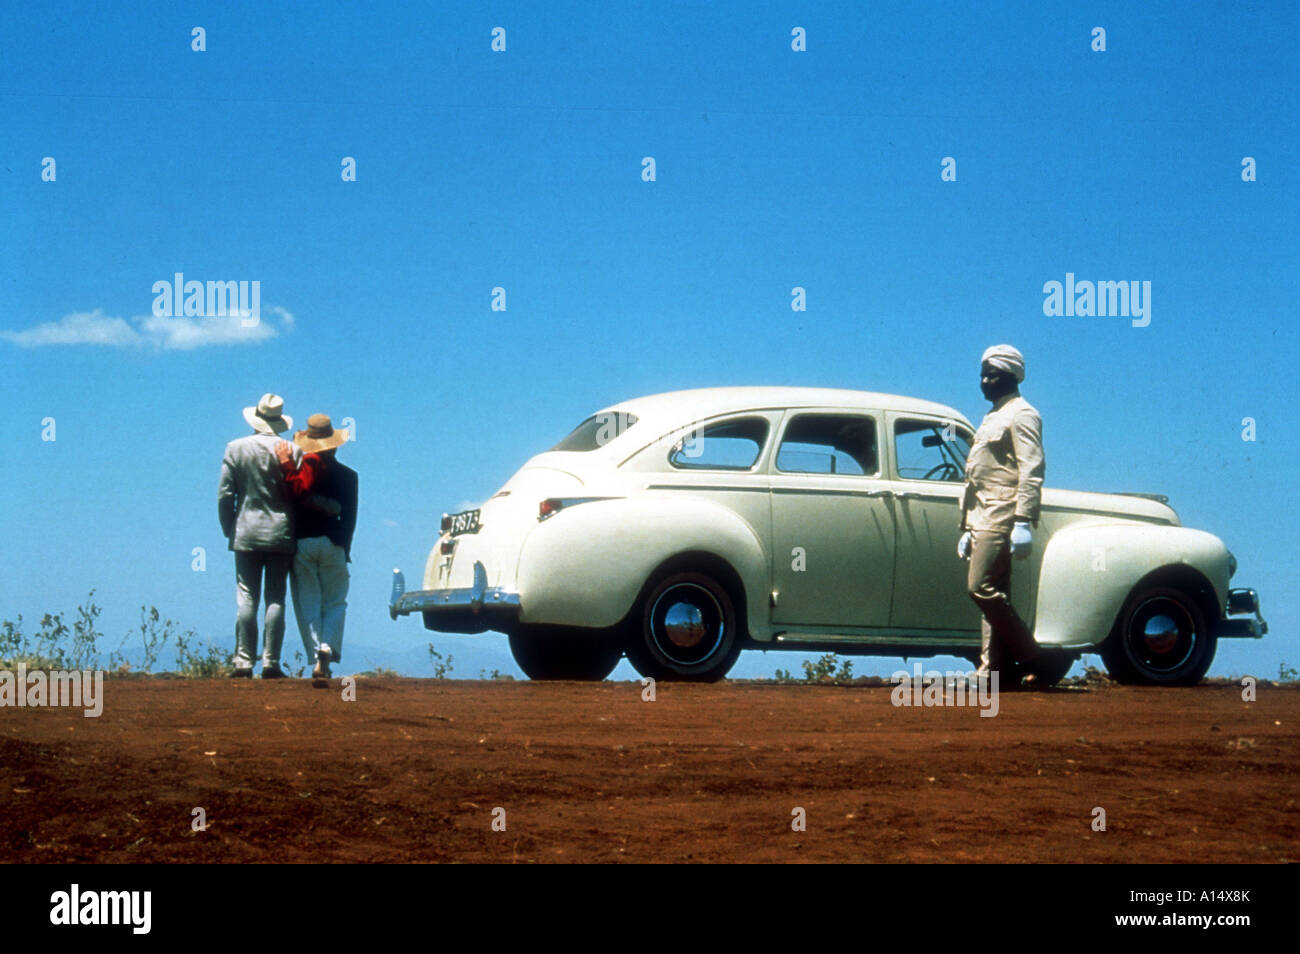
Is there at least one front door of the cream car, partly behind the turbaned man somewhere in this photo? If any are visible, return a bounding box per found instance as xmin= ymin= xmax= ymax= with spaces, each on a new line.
xmin=888 ymin=412 xmax=980 ymax=630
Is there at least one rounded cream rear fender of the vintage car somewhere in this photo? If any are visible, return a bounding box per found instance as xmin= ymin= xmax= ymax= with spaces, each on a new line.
xmin=516 ymin=496 xmax=768 ymax=628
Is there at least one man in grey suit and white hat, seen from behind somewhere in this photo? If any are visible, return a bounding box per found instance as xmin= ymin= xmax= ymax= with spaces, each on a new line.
xmin=217 ymin=394 xmax=305 ymax=678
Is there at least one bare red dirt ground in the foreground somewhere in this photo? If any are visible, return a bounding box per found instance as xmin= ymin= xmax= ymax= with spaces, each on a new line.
xmin=0 ymin=678 xmax=1300 ymax=863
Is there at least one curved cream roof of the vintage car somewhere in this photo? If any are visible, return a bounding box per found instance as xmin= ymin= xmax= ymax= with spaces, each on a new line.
xmin=598 ymin=386 xmax=969 ymax=424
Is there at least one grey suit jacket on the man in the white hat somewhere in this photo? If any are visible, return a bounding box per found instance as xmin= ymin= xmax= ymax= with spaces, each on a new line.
xmin=217 ymin=434 xmax=302 ymax=554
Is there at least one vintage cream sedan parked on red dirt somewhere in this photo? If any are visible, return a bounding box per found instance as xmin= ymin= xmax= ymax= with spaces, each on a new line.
xmin=389 ymin=387 xmax=1268 ymax=685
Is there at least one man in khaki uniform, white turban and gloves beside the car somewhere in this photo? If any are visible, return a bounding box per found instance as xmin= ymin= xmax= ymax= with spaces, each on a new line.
xmin=957 ymin=344 xmax=1044 ymax=689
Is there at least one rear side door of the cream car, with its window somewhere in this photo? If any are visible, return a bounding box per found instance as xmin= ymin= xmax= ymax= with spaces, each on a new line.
xmin=771 ymin=409 xmax=894 ymax=628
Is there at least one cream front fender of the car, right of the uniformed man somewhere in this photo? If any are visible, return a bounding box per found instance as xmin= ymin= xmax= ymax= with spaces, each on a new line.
xmin=1034 ymin=524 xmax=1230 ymax=649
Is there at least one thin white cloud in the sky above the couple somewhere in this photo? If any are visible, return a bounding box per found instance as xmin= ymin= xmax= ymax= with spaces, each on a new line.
xmin=0 ymin=305 xmax=294 ymax=351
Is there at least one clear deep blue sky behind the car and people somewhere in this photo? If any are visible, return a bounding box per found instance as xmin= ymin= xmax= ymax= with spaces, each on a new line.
xmin=0 ymin=3 xmax=1300 ymax=677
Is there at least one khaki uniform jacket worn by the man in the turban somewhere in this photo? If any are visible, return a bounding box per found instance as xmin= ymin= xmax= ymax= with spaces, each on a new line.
xmin=961 ymin=394 xmax=1045 ymax=533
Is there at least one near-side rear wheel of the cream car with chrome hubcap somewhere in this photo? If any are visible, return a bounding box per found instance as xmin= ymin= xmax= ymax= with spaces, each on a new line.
xmin=628 ymin=573 xmax=740 ymax=682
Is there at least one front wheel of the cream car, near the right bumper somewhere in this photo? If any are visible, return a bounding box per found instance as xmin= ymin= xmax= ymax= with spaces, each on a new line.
xmin=1101 ymin=586 xmax=1214 ymax=686
